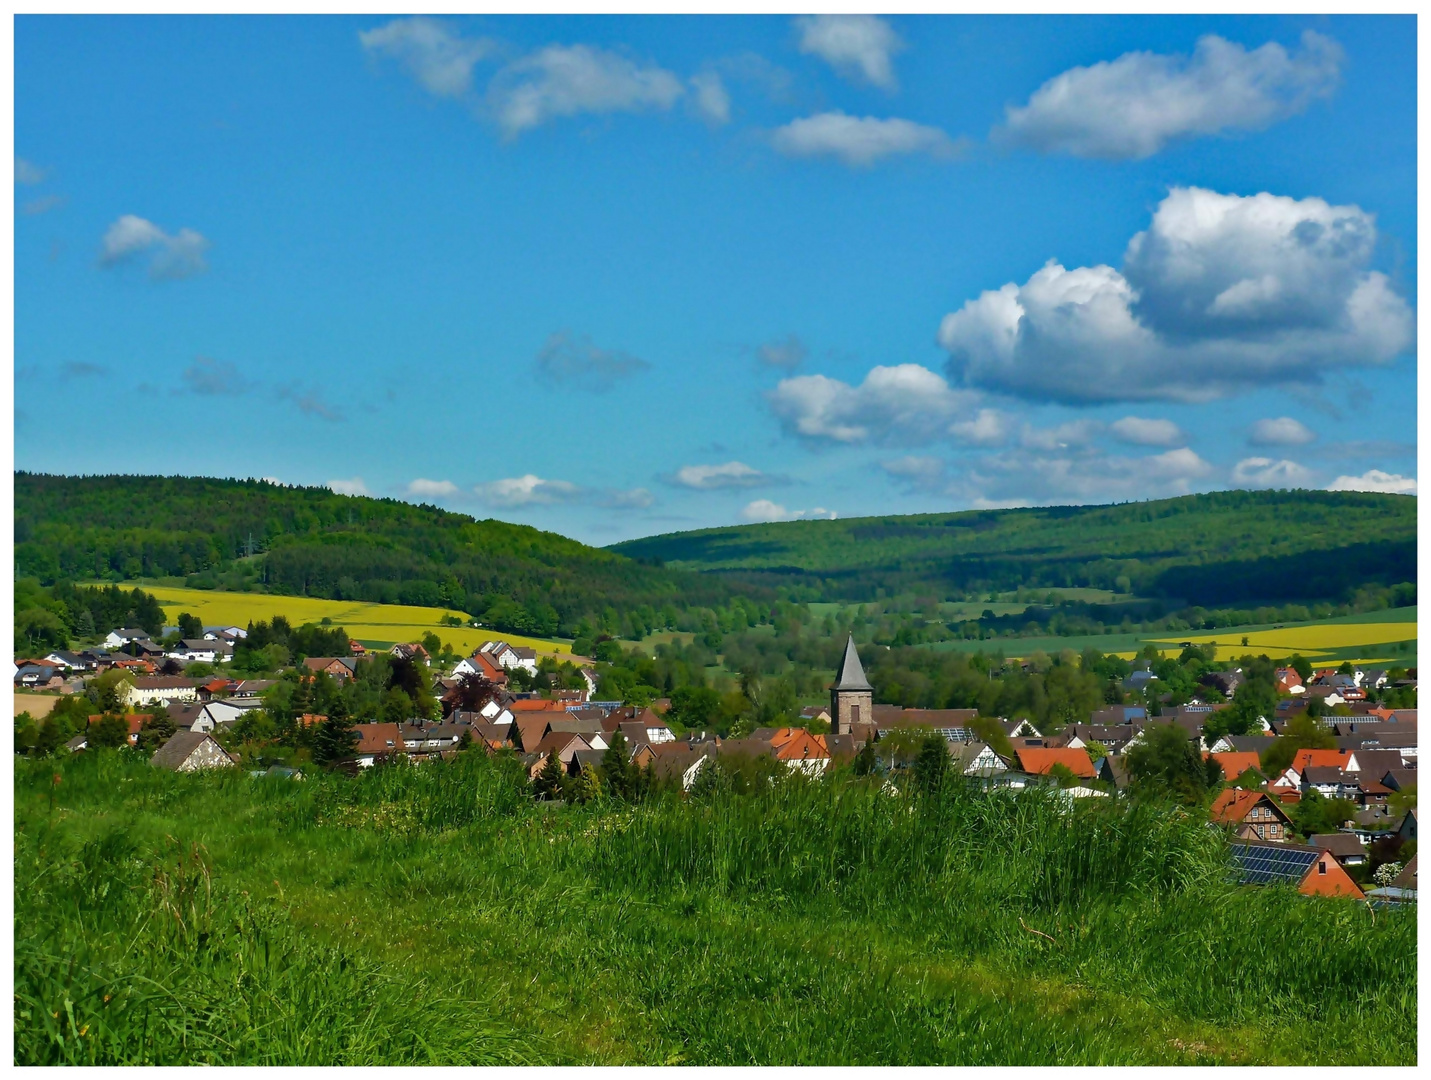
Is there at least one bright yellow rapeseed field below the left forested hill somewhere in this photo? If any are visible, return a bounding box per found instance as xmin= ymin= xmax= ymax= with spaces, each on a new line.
xmin=145 ymin=585 xmax=571 ymax=655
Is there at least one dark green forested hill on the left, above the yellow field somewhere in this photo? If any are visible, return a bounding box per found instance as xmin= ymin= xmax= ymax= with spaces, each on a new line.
xmin=14 ymin=472 xmax=758 ymax=635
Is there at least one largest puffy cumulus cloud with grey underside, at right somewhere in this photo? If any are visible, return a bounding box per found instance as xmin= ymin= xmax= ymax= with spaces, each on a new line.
xmin=939 ymin=187 xmax=1415 ymax=402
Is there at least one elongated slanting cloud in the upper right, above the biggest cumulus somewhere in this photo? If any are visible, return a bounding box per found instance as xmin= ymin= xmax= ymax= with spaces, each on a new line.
xmin=995 ymin=30 xmax=1342 ymax=159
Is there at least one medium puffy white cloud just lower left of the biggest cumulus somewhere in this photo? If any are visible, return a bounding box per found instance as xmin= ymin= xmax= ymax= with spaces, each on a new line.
xmin=766 ymin=363 xmax=977 ymax=445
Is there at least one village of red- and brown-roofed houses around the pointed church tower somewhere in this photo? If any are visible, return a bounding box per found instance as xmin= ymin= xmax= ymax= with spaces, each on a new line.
xmin=14 ymin=627 xmax=1418 ymax=903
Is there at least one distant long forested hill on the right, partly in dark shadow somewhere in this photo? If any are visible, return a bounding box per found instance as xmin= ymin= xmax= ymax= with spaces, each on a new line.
xmin=611 ymin=491 xmax=1417 ymax=605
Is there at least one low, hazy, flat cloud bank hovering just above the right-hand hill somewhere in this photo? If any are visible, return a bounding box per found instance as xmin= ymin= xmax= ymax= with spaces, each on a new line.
xmin=949 ymin=448 xmax=1213 ymax=506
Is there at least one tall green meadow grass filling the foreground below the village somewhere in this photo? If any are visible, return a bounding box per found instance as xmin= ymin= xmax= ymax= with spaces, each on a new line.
xmin=16 ymin=752 xmax=1417 ymax=1064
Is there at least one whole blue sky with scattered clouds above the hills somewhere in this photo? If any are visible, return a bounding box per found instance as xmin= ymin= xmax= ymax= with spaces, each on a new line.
xmin=14 ymin=17 xmax=1417 ymax=544
